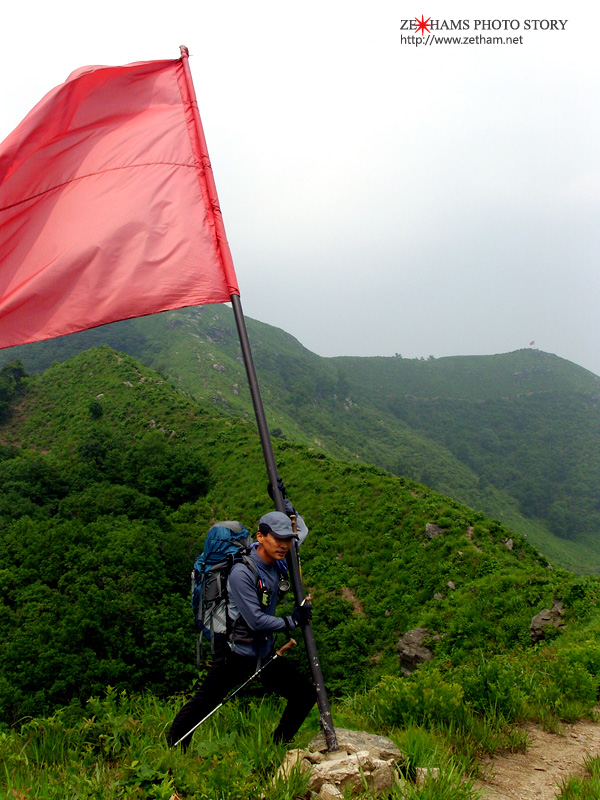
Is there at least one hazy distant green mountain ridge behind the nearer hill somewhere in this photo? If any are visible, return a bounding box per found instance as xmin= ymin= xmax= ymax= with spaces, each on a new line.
xmin=5 ymin=306 xmax=600 ymax=572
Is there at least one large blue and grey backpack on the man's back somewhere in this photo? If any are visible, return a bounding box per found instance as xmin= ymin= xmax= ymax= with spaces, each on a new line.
xmin=192 ymin=521 xmax=260 ymax=653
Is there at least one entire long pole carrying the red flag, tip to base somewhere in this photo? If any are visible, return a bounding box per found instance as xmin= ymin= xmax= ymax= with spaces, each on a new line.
xmin=180 ymin=45 xmax=338 ymax=751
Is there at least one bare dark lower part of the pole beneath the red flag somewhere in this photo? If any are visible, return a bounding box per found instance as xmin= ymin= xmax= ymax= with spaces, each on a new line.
xmin=231 ymin=294 xmax=338 ymax=751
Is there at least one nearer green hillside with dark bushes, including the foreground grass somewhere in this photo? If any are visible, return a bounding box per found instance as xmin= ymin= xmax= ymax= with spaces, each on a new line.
xmin=0 ymin=347 xmax=600 ymax=800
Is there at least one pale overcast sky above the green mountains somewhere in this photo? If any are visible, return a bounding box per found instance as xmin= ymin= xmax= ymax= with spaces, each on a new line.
xmin=0 ymin=0 xmax=600 ymax=374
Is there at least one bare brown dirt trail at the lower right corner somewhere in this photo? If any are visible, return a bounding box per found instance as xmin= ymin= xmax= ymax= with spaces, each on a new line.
xmin=476 ymin=720 xmax=600 ymax=800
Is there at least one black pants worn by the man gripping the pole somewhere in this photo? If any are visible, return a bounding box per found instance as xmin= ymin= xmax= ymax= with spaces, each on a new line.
xmin=167 ymin=648 xmax=317 ymax=750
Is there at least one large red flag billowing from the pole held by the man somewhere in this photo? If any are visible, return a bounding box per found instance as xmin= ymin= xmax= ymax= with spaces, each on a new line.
xmin=0 ymin=53 xmax=239 ymax=348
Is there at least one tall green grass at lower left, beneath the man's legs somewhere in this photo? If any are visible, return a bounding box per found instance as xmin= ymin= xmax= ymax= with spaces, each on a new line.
xmin=0 ymin=690 xmax=314 ymax=800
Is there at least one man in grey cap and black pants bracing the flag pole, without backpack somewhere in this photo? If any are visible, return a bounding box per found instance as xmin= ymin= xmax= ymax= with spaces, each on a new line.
xmin=167 ymin=511 xmax=317 ymax=750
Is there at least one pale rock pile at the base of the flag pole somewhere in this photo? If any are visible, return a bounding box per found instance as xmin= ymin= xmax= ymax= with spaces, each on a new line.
xmin=278 ymin=728 xmax=404 ymax=800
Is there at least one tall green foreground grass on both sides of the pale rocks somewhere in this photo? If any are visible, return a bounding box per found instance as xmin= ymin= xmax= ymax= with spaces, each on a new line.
xmin=0 ymin=638 xmax=600 ymax=800
